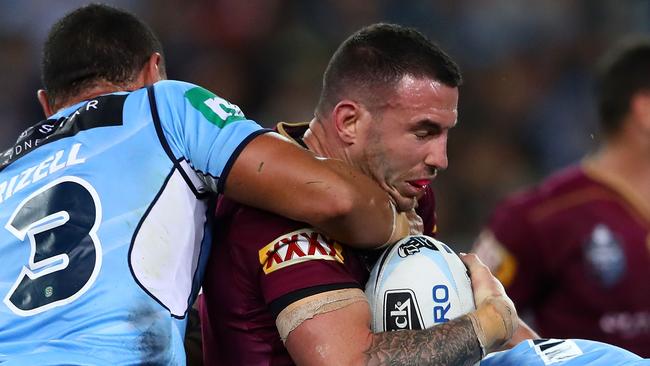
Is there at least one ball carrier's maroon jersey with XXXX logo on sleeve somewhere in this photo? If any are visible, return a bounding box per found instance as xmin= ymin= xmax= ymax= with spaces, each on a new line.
xmin=199 ymin=124 xmax=435 ymax=365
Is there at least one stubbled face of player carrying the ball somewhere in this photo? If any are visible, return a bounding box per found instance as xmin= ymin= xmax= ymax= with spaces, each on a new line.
xmin=359 ymin=76 xmax=458 ymax=207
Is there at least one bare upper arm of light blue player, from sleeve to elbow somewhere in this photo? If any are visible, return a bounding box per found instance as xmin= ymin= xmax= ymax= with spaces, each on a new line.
xmin=224 ymin=133 xmax=351 ymax=225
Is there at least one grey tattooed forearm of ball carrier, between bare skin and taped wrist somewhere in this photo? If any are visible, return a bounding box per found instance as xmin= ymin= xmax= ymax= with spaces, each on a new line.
xmin=365 ymin=316 xmax=481 ymax=365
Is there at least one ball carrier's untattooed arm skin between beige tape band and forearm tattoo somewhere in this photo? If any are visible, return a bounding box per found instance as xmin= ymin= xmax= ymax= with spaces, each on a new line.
xmin=285 ymin=301 xmax=372 ymax=365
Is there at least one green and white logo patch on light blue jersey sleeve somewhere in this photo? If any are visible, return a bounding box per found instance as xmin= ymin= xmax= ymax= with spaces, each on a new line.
xmin=185 ymin=86 xmax=246 ymax=128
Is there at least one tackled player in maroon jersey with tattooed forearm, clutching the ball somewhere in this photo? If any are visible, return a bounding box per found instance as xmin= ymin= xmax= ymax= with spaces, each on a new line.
xmin=201 ymin=24 xmax=517 ymax=365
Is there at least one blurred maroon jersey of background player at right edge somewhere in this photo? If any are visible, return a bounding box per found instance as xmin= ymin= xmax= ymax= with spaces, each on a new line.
xmin=475 ymin=164 xmax=650 ymax=357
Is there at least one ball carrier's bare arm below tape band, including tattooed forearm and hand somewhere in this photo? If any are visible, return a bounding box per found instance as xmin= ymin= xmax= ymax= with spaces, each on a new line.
xmin=285 ymin=254 xmax=518 ymax=365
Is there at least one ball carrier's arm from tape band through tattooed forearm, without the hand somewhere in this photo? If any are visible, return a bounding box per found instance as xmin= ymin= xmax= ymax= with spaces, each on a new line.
xmin=285 ymin=302 xmax=481 ymax=365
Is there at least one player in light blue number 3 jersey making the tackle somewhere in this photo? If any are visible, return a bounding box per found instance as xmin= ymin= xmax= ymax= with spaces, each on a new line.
xmin=0 ymin=5 xmax=412 ymax=365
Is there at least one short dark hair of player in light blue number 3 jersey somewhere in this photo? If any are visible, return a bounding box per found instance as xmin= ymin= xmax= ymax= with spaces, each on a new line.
xmin=41 ymin=4 xmax=164 ymax=108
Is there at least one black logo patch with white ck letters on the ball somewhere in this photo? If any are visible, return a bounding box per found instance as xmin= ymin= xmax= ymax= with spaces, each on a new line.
xmin=384 ymin=289 xmax=424 ymax=331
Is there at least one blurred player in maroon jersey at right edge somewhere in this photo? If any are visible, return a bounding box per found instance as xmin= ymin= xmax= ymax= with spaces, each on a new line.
xmin=475 ymin=39 xmax=650 ymax=357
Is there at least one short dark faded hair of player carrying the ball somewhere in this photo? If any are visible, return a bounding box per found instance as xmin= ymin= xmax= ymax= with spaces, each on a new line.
xmin=316 ymin=23 xmax=462 ymax=113
